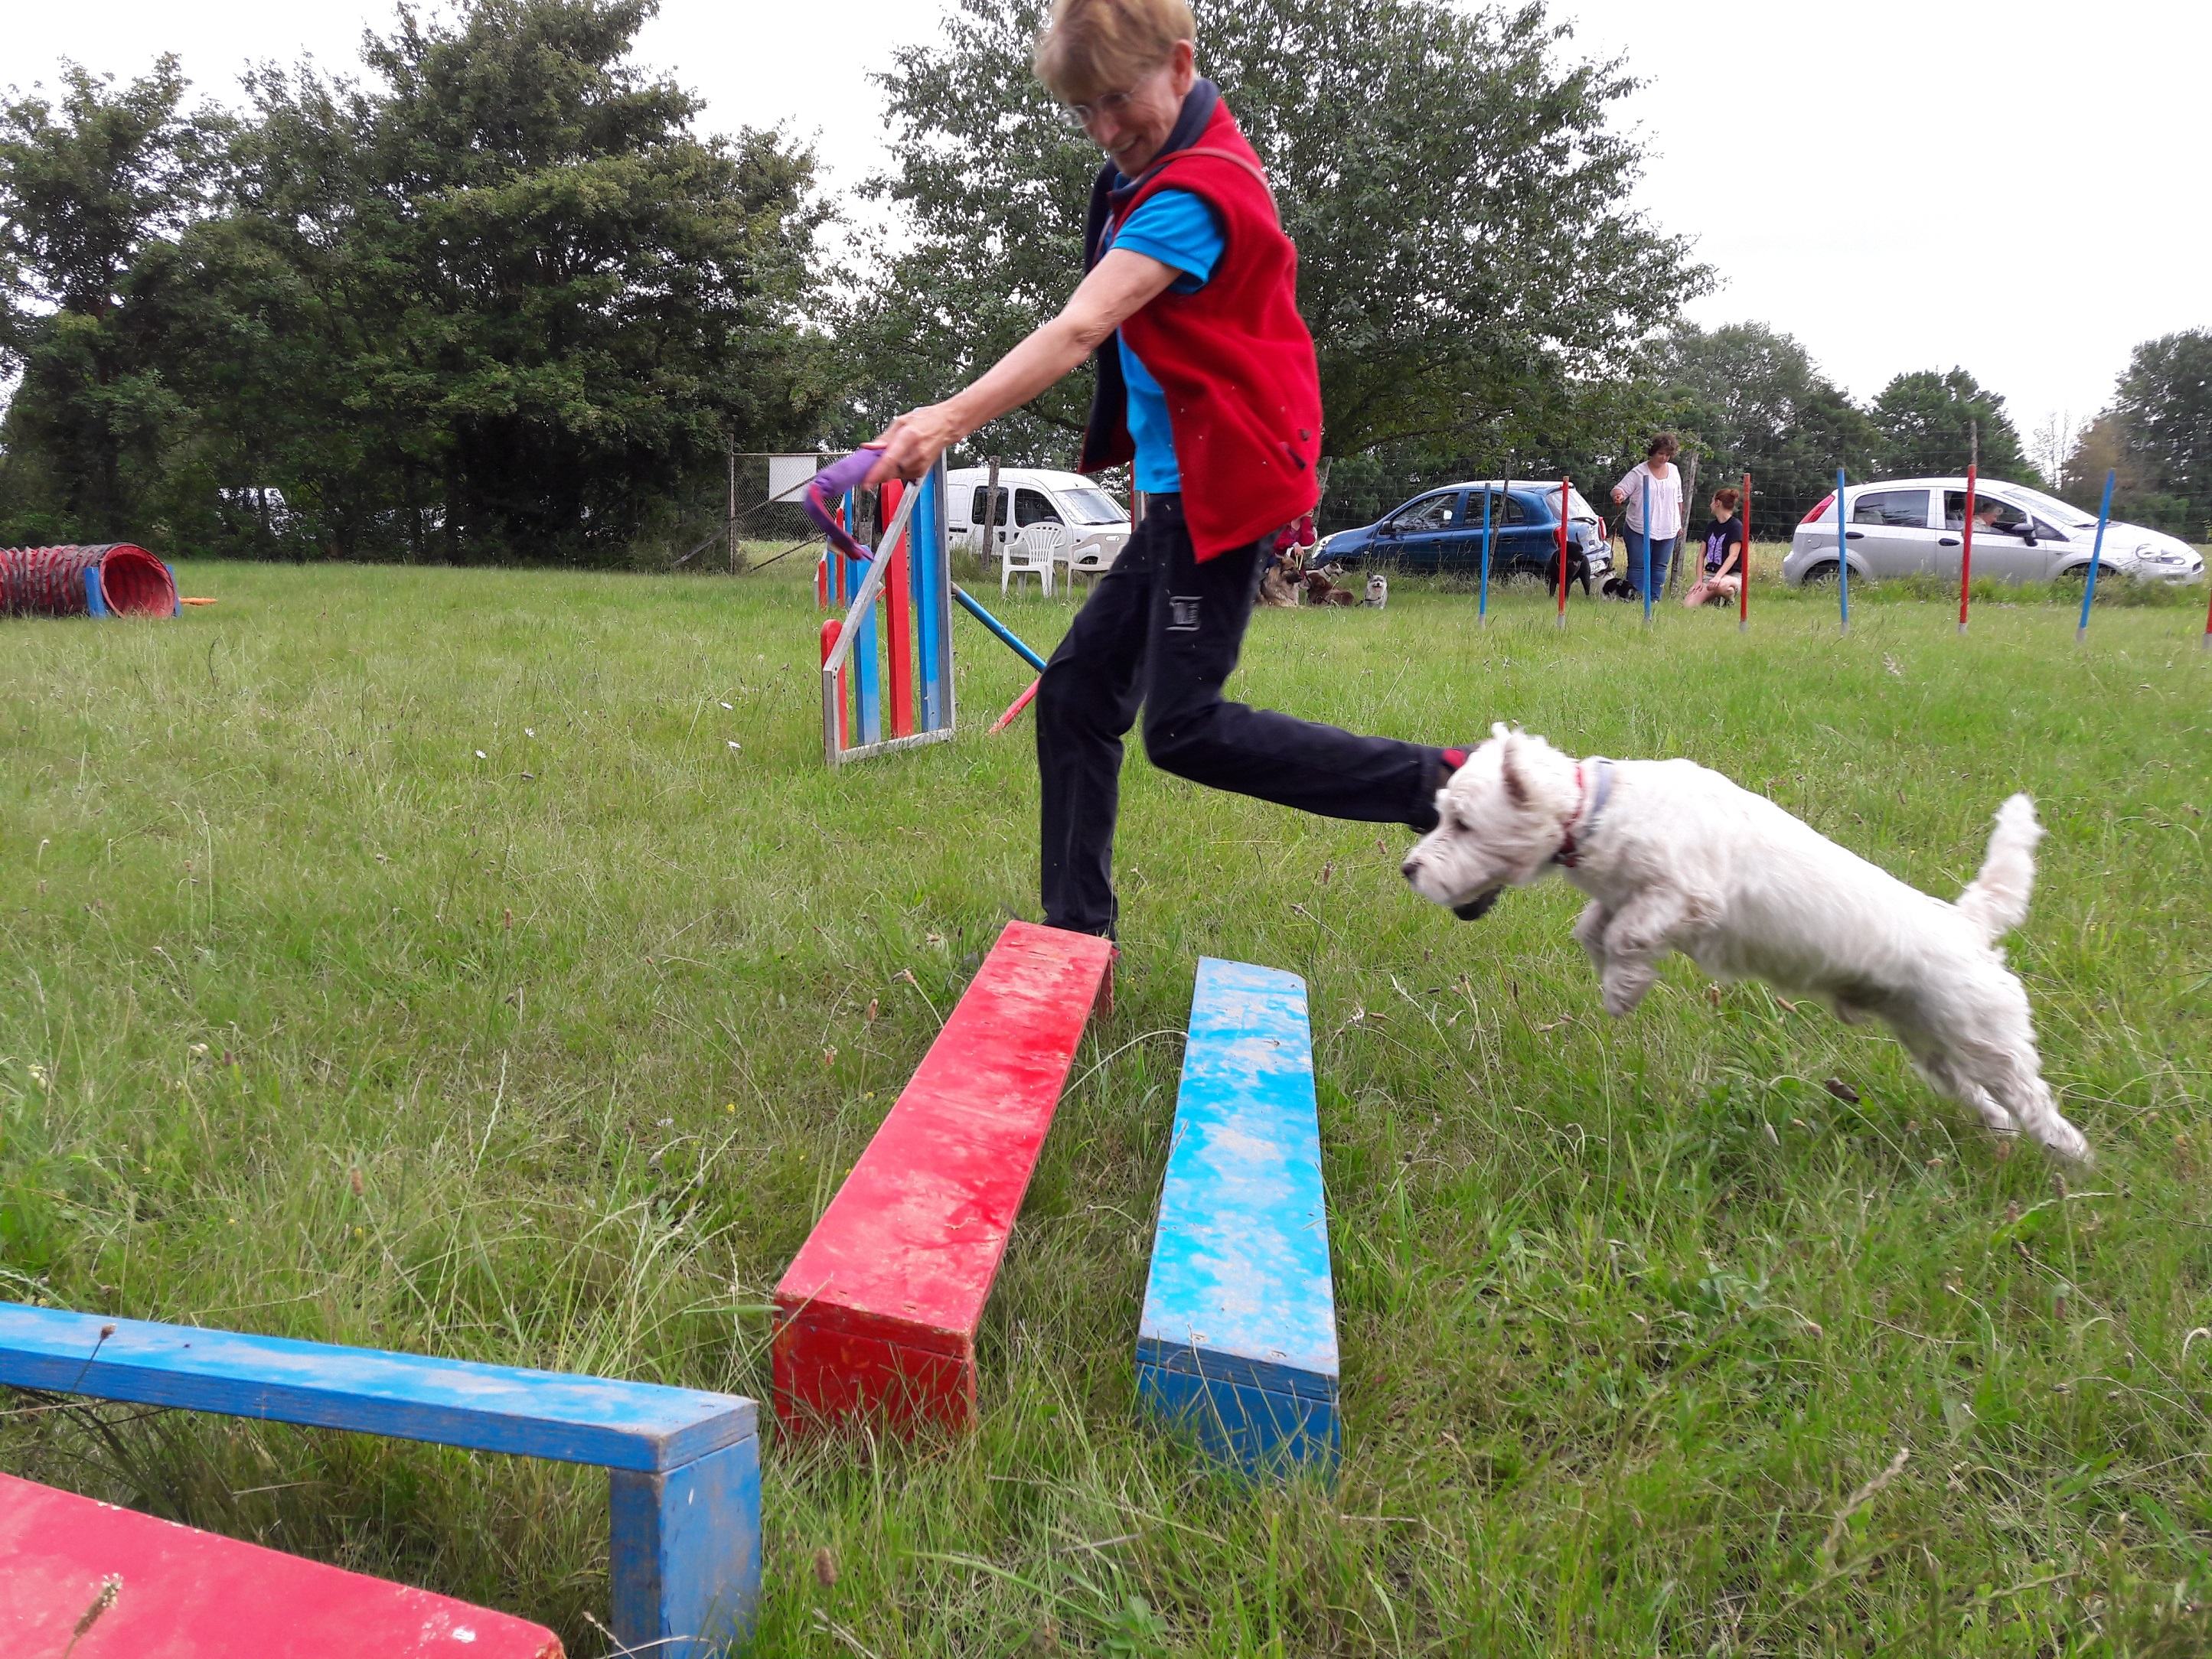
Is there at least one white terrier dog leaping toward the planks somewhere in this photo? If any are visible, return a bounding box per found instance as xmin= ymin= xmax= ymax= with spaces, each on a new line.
xmin=1405 ymin=725 xmax=2088 ymax=1162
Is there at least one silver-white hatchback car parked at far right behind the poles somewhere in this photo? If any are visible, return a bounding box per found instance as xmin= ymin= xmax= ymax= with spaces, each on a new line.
xmin=1783 ymin=477 xmax=2205 ymax=586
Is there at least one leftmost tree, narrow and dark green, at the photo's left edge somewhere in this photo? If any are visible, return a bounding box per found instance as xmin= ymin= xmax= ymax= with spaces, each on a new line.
xmin=0 ymin=57 xmax=228 ymax=539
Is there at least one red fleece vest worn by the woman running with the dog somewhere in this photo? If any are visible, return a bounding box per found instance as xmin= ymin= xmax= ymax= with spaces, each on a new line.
xmin=1079 ymin=104 xmax=1320 ymax=562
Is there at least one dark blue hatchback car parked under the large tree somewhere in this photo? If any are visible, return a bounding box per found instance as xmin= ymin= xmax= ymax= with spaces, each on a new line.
xmin=1312 ymin=477 xmax=1613 ymax=577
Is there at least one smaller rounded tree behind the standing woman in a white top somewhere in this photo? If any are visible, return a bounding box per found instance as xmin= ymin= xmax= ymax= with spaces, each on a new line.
xmin=1652 ymin=323 xmax=1882 ymax=537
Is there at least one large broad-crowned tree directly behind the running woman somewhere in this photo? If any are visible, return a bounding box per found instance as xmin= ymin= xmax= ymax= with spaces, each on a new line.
xmin=847 ymin=0 xmax=1705 ymax=473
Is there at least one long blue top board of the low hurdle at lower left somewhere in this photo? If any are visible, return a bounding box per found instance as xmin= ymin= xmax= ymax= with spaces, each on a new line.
xmin=0 ymin=1303 xmax=756 ymax=1471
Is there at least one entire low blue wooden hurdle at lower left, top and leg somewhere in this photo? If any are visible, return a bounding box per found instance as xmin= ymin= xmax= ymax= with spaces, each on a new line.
xmin=0 ymin=1303 xmax=761 ymax=1659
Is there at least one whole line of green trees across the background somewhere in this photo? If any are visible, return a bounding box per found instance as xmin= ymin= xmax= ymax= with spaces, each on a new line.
xmin=0 ymin=0 xmax=2212 ymax=564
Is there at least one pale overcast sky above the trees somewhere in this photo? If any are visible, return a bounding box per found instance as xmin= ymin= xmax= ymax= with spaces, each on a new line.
xmin=0 ymin=0 xmax=2212 ymax=458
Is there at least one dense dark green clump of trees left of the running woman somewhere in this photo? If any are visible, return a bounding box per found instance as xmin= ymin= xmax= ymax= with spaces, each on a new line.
xmin=0 ymin=0 xmax=827 ymax=562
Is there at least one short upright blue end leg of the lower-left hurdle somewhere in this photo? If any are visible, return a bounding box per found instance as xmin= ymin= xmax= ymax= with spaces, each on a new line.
xmin=608 ymin=1440 xmax=761 ymax=1659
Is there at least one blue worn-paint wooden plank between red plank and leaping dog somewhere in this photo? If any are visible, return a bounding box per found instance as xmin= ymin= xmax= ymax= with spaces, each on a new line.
xmin=1137 ymin=956 xmax=1340 ymax=1468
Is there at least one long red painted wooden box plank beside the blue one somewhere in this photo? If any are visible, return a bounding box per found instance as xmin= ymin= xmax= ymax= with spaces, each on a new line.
xmin=775 ymin=922 xmax=1113 ymax=1429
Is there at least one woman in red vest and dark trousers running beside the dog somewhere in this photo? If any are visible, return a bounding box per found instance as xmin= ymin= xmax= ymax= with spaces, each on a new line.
xmin=869 ymin=0 xmax=1467 ymax=934
